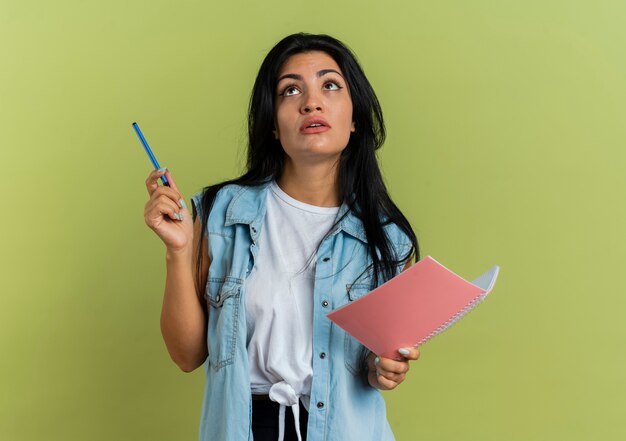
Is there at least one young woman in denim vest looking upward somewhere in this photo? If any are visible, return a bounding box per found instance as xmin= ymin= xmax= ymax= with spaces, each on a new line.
xmin=145 ymin=34 xmax=419 ymax=441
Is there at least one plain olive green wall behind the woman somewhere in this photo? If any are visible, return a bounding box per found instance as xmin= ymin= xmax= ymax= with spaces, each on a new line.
xmin=0 ymin=0 xmax=626 ymax=441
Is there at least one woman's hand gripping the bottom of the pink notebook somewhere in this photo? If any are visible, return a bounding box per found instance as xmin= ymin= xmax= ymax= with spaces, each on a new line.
xmin=367 ymin=347 xmax=420 ymax=390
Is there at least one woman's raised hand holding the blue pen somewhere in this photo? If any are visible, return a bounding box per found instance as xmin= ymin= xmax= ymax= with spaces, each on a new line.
xmin=144 ymin=169 xmax=193 ymax=252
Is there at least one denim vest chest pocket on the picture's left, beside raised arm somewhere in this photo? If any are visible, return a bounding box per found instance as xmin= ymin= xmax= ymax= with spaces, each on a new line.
xmin=206 ymin=277 xmax=242 ymax=370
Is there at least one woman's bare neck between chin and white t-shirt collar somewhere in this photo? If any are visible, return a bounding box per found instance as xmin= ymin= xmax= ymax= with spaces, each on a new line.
xmin=277 ymin=157 xmax=341 ymax=207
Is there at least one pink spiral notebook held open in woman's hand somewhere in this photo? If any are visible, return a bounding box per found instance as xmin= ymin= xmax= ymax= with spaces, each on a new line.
xmin=327 ymin=256 xmax=500 ymax=358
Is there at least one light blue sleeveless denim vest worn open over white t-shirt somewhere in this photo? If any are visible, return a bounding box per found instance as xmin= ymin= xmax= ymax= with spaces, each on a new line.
xmin=192 ymin=185 xmax=411 ymax=441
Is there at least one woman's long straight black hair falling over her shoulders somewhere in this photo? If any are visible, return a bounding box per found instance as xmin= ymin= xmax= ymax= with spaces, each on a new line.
xmin=194 ymin=33 xmax=419 ymax=292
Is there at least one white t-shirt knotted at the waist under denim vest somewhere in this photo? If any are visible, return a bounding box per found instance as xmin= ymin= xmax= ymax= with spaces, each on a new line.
xmin=245 ymin=182 xmax=339 ymax=434
